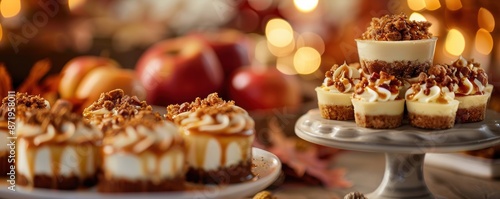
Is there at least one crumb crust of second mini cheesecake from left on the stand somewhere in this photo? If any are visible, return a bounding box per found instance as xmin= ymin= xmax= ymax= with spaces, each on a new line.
xmin=356 ymin=113 xmax=403 ymax=129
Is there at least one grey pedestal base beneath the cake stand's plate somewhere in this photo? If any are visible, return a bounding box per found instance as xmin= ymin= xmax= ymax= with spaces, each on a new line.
xmin=367 ymin=153 xmax=435 ymax=199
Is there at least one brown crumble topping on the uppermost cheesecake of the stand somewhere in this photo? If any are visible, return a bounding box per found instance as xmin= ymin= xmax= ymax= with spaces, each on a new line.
xmin=361 ymin=13 xmax=432 ymax=41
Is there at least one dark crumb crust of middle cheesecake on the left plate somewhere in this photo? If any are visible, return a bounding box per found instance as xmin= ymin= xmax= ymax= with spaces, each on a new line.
xmin=97 ymin=175 xmax=186 ymax=193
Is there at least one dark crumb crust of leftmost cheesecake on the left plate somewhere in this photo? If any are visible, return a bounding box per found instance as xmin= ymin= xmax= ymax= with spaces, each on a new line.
xmin=17 ymin=174 xmax=97 ymax=190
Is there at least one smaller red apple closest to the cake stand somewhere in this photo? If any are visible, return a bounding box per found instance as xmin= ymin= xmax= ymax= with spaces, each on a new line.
xmin=229 ymin=67 xmax=301 ymax=111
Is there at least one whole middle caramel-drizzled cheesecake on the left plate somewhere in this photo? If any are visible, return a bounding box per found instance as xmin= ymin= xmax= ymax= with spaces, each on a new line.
xmin=98 ymin=111 xmax=186 ymax=192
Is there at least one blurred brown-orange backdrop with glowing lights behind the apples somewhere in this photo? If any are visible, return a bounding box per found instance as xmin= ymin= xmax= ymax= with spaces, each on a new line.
xmin=0 ymin=0 xmax=500 ymax=109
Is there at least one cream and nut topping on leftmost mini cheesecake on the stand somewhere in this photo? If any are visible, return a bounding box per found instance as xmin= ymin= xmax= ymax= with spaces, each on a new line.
xmin=321 ymin=62 xmax=361 ymax=93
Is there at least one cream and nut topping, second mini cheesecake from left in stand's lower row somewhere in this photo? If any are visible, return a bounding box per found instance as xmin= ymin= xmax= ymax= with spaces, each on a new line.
xmin=353 ymin=71 xmax=403 ymax=102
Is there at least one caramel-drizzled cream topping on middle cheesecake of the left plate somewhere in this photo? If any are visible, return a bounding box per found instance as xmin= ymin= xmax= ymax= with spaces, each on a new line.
xmin=104 ymin=118 xmax=181 ymax=153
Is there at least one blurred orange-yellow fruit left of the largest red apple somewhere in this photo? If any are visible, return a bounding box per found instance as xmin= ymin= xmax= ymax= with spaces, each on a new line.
xmin=59 ymin=56 xmax=146 ymax=112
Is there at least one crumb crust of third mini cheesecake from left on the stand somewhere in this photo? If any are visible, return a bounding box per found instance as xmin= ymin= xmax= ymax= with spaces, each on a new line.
xmin=408 ymin=113 xmax=455 ymax=129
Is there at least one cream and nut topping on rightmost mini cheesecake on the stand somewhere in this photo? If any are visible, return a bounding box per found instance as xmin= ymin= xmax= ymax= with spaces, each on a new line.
xmin=448 ymin=56 xmax=488 ymax=95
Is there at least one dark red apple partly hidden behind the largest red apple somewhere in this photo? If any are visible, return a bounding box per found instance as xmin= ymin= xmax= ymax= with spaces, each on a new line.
xmin=195 ymin=29 xmax=250 ymax=79
